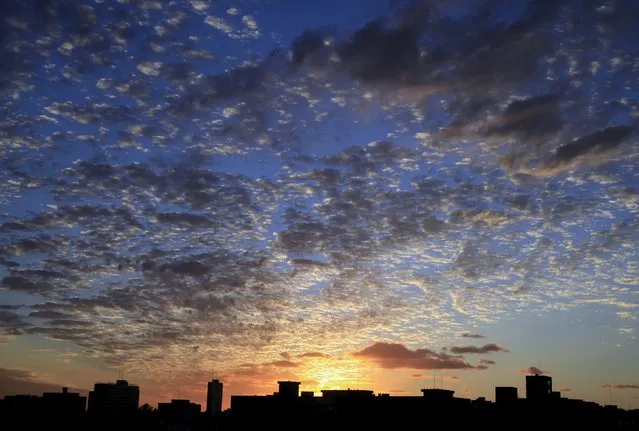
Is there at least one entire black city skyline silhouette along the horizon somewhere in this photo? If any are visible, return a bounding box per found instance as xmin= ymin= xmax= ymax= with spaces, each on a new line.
xmin=0 ymin=369 xmax=639 ymax=431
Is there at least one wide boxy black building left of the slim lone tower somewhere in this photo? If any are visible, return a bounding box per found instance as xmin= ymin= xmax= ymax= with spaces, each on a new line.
xmin=89 ymin=380 xmax=140 ymax=417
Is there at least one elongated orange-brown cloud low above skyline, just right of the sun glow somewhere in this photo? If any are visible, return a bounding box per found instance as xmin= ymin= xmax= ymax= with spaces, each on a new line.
xmin=352 ymin=341 xmax=473 ymax=370
